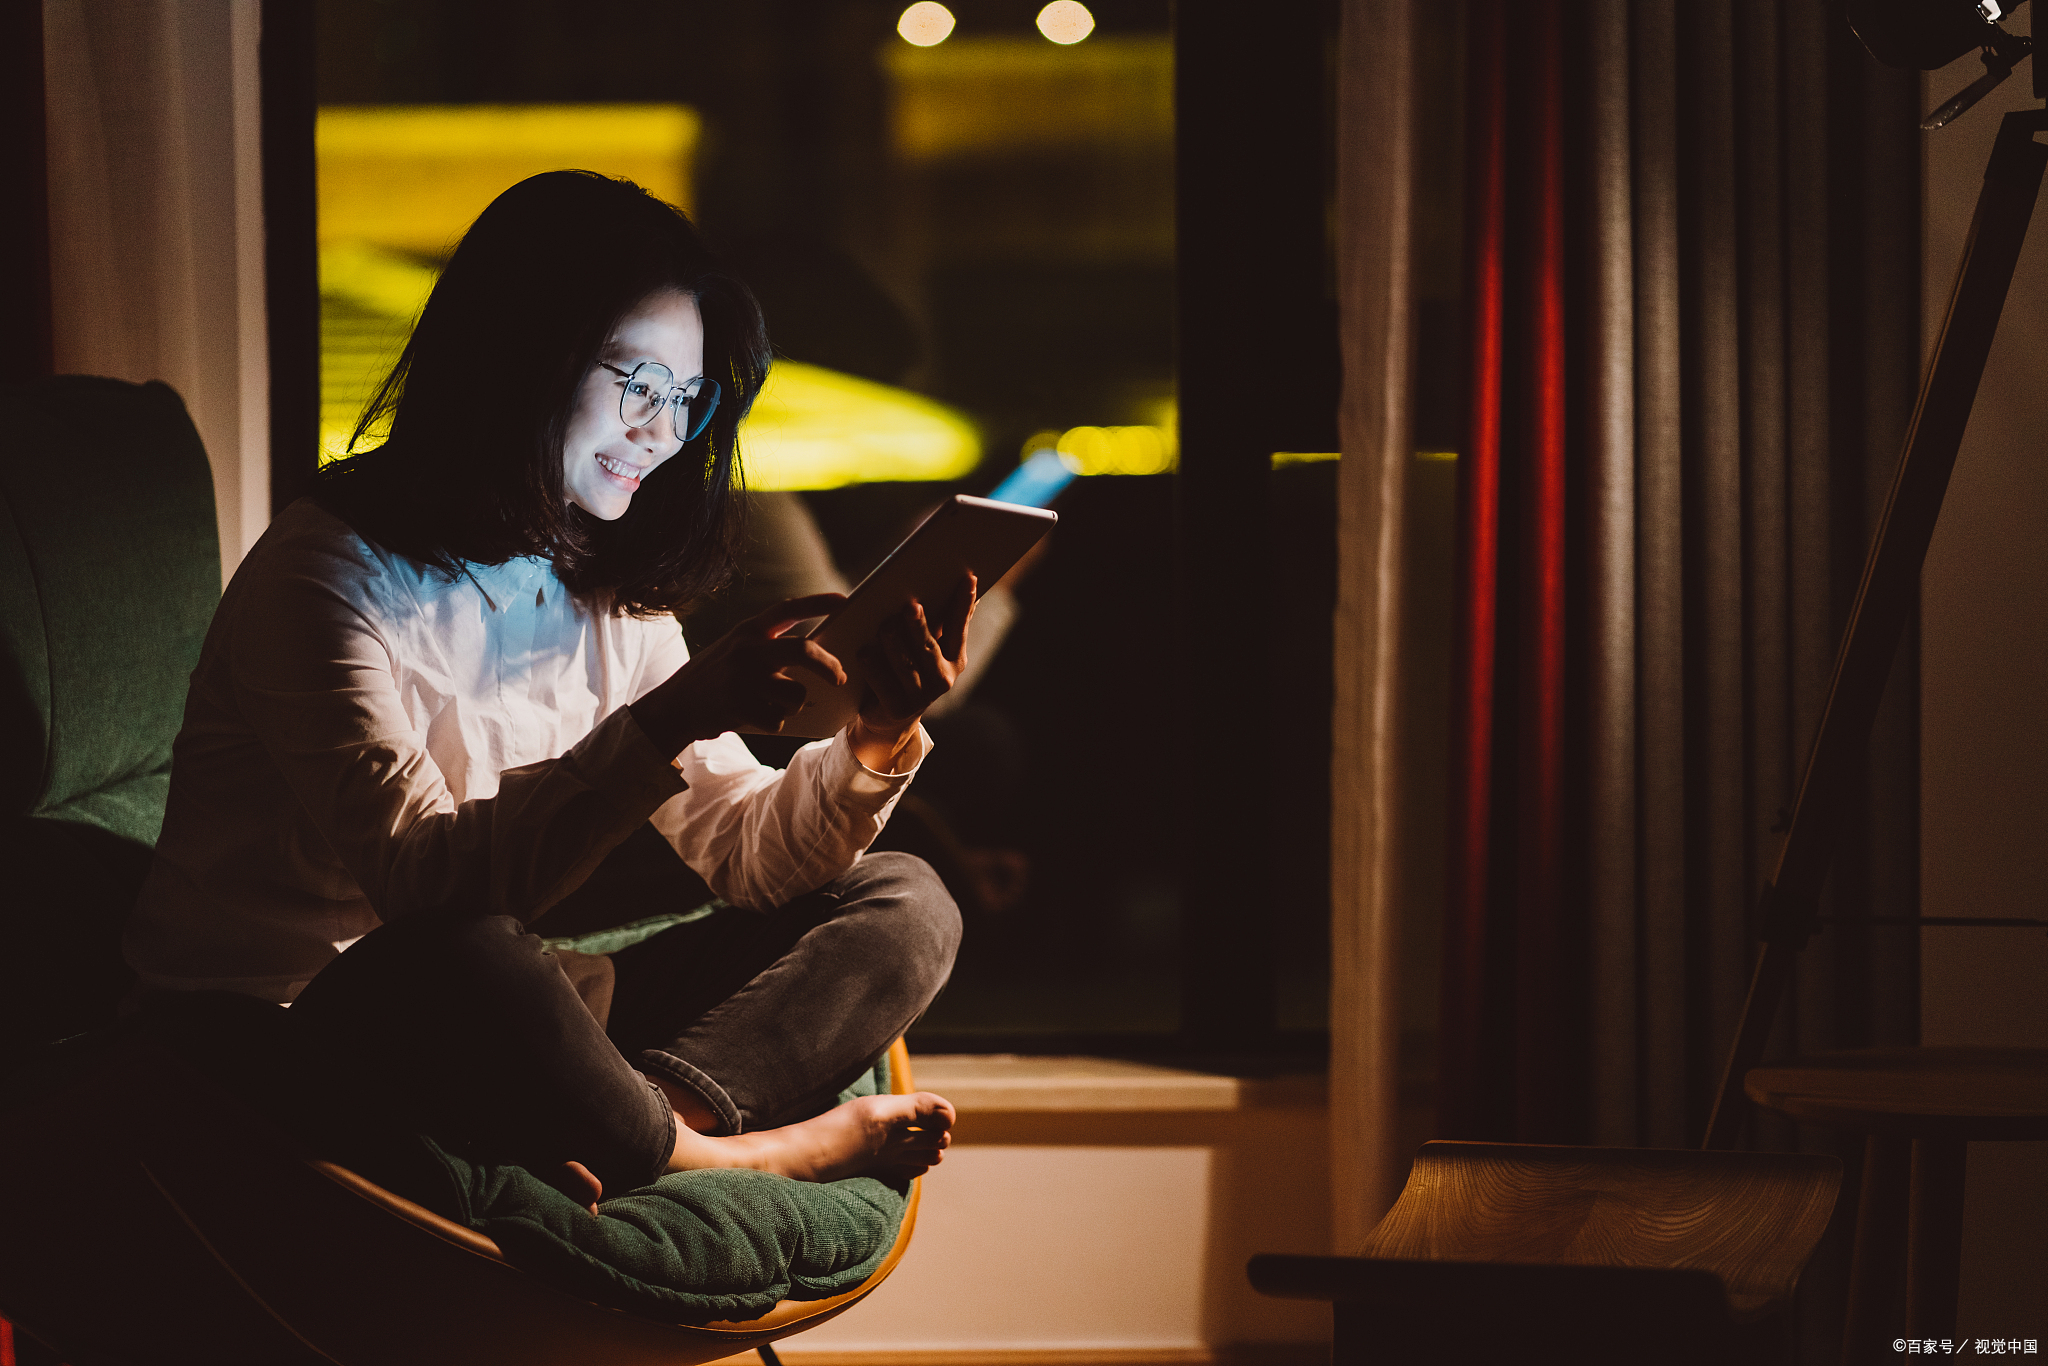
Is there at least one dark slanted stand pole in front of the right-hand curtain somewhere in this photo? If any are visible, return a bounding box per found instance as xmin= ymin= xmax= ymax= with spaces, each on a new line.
xmin=1702 ymin=104 xmax=2048 ymax=1149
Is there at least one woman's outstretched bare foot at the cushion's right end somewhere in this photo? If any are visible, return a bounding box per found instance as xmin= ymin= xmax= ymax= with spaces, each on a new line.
xmin=668 ymin=1092 xmax=954 ymax=1182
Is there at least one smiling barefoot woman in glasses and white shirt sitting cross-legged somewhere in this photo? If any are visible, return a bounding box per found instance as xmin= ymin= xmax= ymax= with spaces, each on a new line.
xmin=125 ymin=172 xmax=973 ymax=1200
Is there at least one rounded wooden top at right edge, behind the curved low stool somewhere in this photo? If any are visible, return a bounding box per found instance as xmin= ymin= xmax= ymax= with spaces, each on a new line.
xmin=1743 ymin=1049 xmax=2048 ymax=1141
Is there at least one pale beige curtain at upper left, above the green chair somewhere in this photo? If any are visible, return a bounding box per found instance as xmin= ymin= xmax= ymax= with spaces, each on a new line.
xmin=41 ymin=0 xmax=270 ymax=582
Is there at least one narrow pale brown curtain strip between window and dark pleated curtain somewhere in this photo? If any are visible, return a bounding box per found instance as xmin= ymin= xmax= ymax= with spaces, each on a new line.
xmin=1329 ymin=0 xmax=1417 ymax=1251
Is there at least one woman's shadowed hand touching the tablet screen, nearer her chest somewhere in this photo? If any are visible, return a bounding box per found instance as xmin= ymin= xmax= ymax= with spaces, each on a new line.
xmin=629 ymin=594 xmax=846 ymax=754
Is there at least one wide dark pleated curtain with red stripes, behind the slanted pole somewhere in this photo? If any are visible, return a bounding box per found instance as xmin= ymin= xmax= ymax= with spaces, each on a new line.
xmin=1440 ymin=0 xmax=1919 ymax=1179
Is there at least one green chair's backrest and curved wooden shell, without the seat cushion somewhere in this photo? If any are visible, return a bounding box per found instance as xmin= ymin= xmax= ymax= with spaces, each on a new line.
xmin=0 ymin=377 xmax=918 ymax=1366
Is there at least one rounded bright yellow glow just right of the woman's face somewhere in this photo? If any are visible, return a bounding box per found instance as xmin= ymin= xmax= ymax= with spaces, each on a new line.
xmin=739 ymin=360 xmax=981 ymax=489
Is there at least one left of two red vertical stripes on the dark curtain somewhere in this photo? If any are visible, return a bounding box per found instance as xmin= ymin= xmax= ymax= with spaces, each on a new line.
xmin=1438 ymin=0 xmax=1507 ymax=1139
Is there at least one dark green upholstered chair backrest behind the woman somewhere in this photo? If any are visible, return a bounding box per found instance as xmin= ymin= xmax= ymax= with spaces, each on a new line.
xmin=0 ymin=375 xmax=221 ymax=1057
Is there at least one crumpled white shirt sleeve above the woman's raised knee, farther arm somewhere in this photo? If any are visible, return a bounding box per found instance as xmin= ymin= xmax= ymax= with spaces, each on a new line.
xmin=633 ymin=629 xmax=932 ymax=909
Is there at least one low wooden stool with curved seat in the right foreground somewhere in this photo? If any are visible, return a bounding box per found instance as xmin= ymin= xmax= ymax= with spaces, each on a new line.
xmin=1247 ymin=1143 xmax=1841 ymax=1366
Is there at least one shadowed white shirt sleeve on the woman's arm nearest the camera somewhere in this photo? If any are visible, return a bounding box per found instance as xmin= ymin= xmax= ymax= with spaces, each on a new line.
xmin=229 ymin=557 xmax=684 ymax=920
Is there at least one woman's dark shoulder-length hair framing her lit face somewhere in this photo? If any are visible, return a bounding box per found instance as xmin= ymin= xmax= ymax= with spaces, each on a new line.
xmin=313 ymin=170 xmax=768 ymax=616
